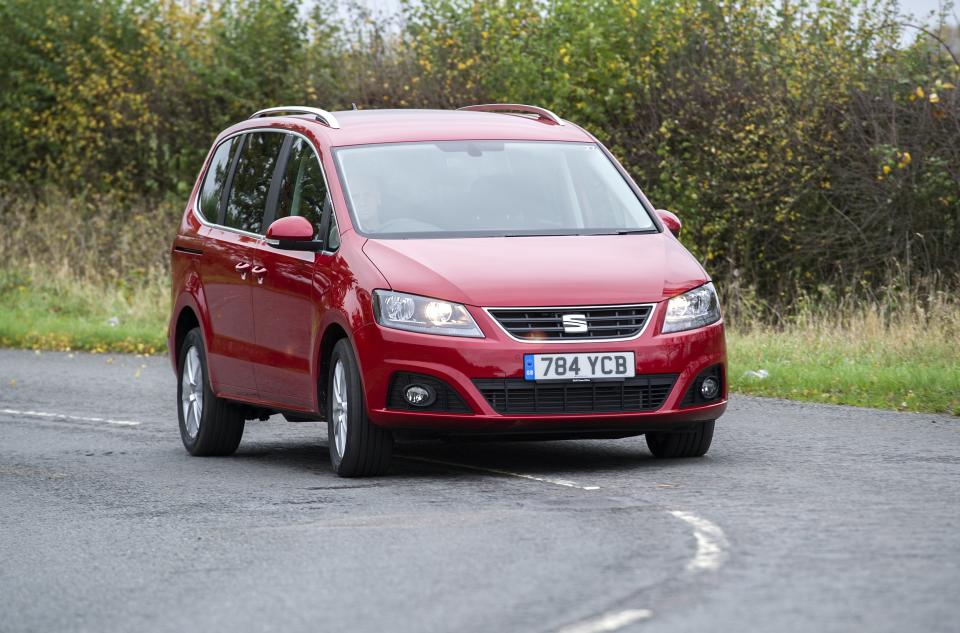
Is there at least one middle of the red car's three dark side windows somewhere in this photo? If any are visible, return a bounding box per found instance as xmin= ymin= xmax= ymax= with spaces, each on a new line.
xmin=223 ymin=132 xmax=285 ymax=233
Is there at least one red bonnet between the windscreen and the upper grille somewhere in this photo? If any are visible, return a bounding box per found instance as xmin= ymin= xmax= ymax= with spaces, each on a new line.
xmin=363 ymin=233 xmax=709 ymax=307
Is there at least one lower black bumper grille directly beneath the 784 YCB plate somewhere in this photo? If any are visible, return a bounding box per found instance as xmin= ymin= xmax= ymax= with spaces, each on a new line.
xmin=473 ymin=374 xmax=677 ymax=414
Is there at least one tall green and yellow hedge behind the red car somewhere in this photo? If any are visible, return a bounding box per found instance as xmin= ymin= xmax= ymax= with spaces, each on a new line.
xmin=0 ymin=0 xmax=960 ymax=304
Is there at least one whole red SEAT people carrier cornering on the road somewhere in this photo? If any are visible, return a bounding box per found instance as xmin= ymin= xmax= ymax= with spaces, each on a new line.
xmin=169 ymin=104 xmax=727 ymax=476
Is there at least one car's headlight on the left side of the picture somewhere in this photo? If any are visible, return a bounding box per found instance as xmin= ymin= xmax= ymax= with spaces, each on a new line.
xmin=373 ymin=290 xmax=483 ymax=338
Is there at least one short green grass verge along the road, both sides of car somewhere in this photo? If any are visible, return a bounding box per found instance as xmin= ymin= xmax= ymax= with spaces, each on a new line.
xmin=0 ymin=271 xmax=960 ymax=415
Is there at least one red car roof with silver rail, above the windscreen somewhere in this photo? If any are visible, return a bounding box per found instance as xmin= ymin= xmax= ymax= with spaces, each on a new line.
xmin=221 ymin=109 xmax=595 ymax=147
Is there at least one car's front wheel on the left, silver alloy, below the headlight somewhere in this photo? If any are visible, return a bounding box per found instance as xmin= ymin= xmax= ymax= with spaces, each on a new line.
xmin=327 ymin=339 xmax=393 ymax=477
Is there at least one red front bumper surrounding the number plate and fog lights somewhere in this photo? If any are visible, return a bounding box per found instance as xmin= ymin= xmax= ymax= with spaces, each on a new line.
xmin=354 ymin=304 xmax=727 ymax=433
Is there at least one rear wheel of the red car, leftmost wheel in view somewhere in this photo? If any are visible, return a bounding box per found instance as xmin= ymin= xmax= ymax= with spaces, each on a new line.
xmin=177 ymin=328 xmax=244 ymax=457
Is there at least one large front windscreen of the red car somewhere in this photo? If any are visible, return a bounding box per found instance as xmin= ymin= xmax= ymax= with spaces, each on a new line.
xmin=335 ymin=141 xmax=656 ymax=238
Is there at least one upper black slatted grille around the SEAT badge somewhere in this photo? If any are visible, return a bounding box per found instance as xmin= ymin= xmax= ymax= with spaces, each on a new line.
xmin=488 ymin=305 xmax=653 ymax=342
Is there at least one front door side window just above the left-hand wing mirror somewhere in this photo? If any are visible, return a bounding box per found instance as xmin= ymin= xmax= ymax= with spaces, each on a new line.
xmin=277 ymin=138 xmax=328 ymax=237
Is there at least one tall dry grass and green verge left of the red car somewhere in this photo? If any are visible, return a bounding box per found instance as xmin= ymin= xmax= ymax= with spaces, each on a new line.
xmin=0 ymin=191 xmax=180 ymax=353
